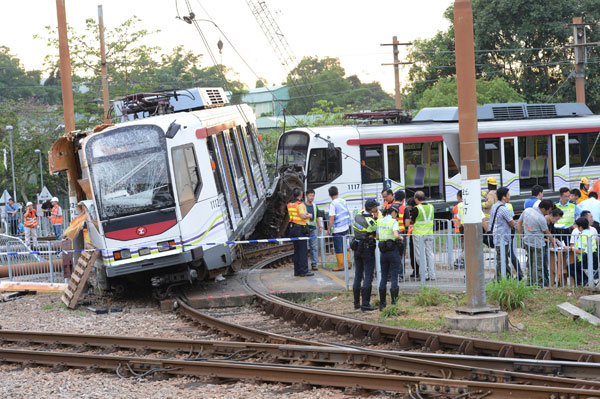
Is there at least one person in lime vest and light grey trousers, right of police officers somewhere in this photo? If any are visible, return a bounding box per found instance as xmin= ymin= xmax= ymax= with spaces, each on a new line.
xmin=410 ymin=191 xmax=436 ymax=280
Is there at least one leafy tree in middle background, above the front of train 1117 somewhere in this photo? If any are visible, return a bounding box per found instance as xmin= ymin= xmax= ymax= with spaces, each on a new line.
xmin=287 ymin=57 xmax=394 ymax=114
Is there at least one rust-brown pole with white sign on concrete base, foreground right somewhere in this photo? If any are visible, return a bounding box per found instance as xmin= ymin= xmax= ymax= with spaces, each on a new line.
xmin=446 ymin=0 xmax=508 ymax=332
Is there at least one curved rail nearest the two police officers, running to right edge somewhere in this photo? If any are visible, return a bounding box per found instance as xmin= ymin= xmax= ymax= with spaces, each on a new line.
xmin=243 ymin=253 xmax=600 ymax=363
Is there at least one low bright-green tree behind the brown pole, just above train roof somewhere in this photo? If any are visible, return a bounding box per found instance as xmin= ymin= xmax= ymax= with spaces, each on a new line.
xmin=416 ymin=78 xmax=524 ymax=109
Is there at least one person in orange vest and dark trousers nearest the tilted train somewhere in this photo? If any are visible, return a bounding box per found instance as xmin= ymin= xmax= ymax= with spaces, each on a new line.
xmin=287 ymin=187 xmax=315 ymax=277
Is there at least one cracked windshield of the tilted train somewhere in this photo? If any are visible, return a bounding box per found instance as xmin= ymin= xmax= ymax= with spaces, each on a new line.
xmin=86 ymin=125 xmax=175 ymax=220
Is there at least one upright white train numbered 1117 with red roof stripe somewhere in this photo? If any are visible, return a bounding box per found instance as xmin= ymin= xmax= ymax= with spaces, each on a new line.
xmin=277 ymin=103 xmax=600 ymax=213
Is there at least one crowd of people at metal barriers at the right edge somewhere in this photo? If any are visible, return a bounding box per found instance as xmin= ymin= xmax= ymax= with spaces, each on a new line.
xmin=468 ymin=177 xmax=600 ymax=287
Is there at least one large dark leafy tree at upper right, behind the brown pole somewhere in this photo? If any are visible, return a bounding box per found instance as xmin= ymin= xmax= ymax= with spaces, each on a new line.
xmin=407 ymin=0 xmax=600 ymax=111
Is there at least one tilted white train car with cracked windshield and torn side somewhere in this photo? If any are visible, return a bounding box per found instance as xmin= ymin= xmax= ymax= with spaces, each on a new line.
xmin=51 ymin=88 xmax=288 ymax=294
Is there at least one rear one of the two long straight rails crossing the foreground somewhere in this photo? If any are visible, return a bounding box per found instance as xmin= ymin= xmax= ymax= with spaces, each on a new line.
xmin=0 ymin=330 xmax=600 ymax=391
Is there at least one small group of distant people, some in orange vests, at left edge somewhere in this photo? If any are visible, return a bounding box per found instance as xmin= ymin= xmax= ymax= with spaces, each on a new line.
xmin=4 ymin=197 xmax=63 ymax=246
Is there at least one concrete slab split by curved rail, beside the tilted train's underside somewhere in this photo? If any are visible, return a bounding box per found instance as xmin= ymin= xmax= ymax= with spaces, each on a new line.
xmin=185 ymin=267 xmax=352 ymax=308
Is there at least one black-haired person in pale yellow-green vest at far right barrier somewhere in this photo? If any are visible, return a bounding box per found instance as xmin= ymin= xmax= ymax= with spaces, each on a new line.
xmin=569 ymin=216 xmax=598 ymax=285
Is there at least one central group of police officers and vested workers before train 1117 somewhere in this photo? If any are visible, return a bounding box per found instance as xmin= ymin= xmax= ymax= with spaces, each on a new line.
xmin=287 ymin=186 xmax=436 ymax=311
